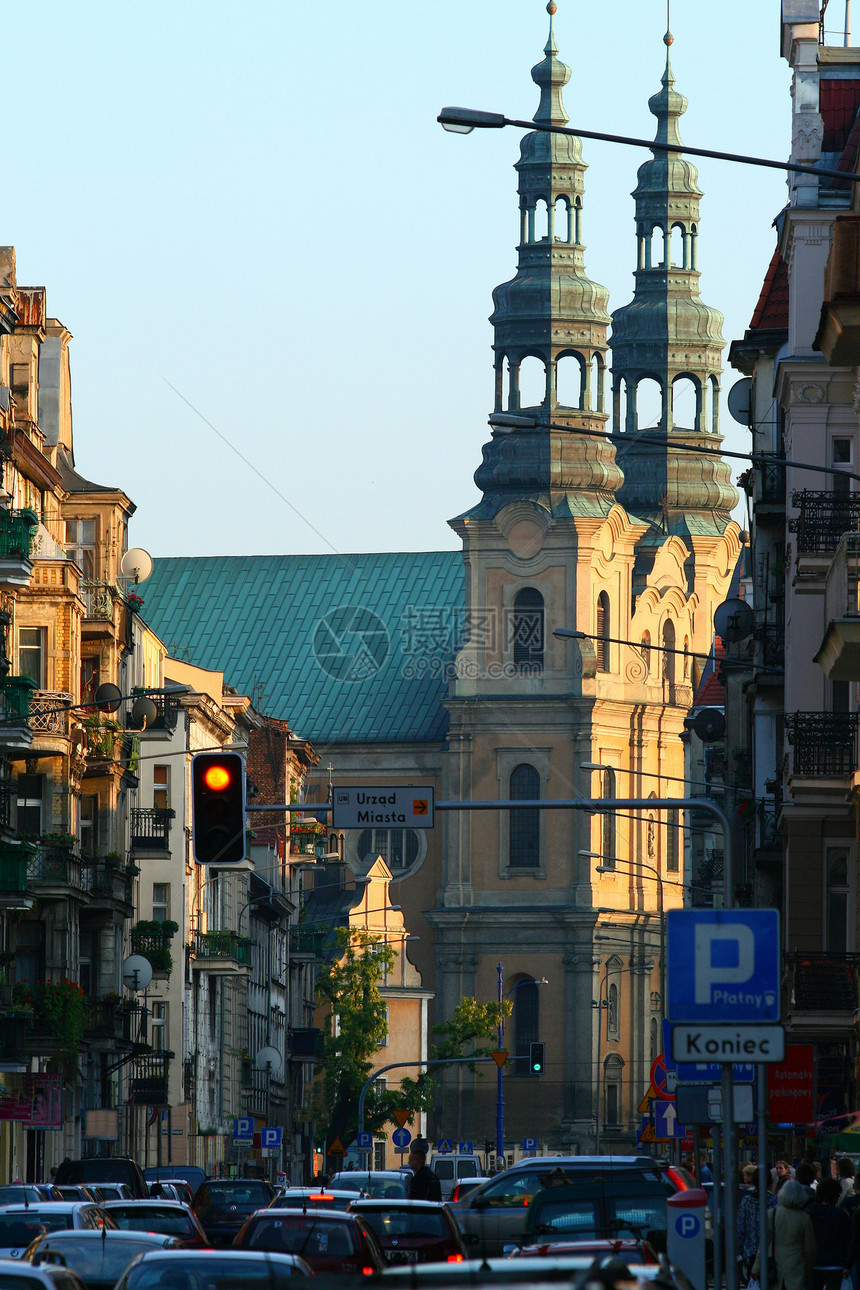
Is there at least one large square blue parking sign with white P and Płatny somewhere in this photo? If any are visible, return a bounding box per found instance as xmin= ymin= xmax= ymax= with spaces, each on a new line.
xmin=667 ymin=909 xmax=780 ymax=1021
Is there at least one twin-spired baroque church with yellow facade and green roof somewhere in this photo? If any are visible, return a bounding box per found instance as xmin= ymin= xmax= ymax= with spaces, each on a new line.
xmin=144 ymin=12 xmax=740 ymax=1152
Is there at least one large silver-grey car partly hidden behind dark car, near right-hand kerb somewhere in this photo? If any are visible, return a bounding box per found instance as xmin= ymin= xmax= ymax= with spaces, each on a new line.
xmin=451 ymin=1156 xmax=677 ymax=1255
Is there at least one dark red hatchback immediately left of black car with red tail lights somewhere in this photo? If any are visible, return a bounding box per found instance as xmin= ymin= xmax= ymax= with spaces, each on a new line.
xmin=232 ymin=1210 xmax=386 ymax=1277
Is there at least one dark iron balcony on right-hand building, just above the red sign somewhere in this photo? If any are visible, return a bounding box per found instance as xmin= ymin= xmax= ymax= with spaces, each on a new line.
xmin=783 ymin=953 xmax=860 ymax=1037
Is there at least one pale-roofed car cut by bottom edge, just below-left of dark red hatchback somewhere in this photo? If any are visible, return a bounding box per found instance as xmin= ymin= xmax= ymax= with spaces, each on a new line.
xmin=116 ymin=1250 xmax=313 ymax=1290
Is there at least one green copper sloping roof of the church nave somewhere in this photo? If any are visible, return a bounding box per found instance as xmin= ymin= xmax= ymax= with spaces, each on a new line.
xmin=141 ymin=551 xmax=464 ymax=747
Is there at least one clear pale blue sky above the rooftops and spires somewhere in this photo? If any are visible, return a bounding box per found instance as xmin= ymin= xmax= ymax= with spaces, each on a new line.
xmin=3 ymin=0 xmax=799 ymax=556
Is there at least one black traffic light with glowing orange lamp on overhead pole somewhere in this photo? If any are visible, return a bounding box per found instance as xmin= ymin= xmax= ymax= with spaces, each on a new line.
xmin=191 ymin=752 xmax=245 ymax=864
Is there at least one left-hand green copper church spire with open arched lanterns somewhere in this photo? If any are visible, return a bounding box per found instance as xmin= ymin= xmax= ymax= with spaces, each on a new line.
xmin=471 ymin=0 xmax=621 ymax=519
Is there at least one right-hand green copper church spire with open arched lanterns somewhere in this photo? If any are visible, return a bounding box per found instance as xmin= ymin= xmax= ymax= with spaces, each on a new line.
xmin=610 ymin=26 xmax=738 ymax=539
